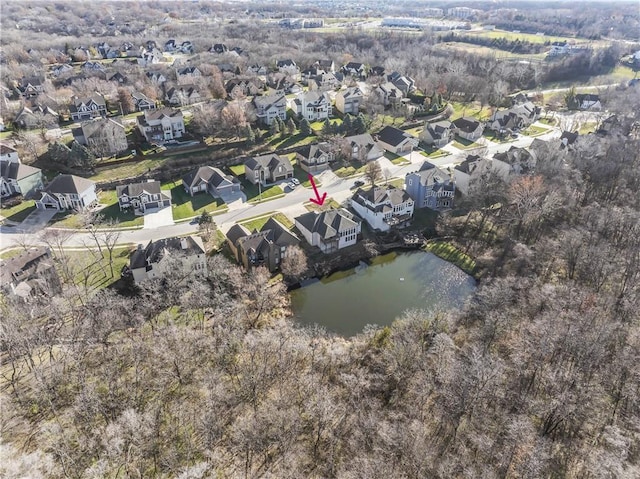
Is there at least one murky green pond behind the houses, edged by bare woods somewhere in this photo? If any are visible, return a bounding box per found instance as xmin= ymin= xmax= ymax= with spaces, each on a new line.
xmin=291 ymin=251 xmax=476 ymax=336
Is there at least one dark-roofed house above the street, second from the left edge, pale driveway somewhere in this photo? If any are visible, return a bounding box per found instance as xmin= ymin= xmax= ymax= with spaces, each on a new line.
xmin=35 ymin=175 xmax=98 ymax=210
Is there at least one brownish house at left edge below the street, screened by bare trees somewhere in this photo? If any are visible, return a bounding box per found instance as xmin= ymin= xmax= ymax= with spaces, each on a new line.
xmin=0 ymin=246 xmax=62 ymax=300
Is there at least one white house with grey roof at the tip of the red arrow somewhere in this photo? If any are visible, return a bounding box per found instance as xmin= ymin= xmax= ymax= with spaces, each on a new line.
xmin=295 ymin=208 xmax=362 ymax=253
